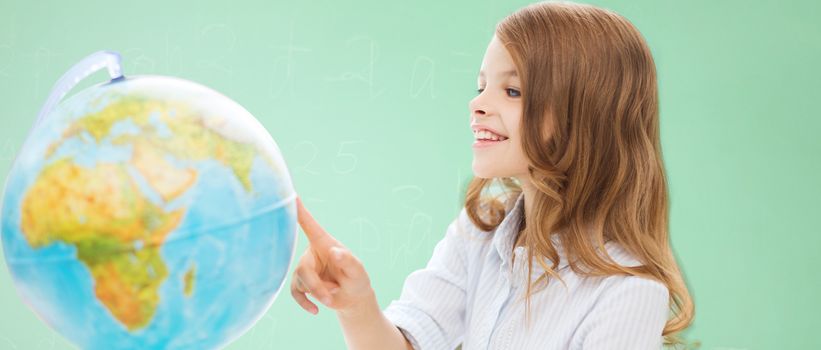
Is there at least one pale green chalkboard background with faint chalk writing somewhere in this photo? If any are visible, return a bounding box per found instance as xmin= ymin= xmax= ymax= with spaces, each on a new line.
xmin=0 ymin=0 xmax=821 ymax=350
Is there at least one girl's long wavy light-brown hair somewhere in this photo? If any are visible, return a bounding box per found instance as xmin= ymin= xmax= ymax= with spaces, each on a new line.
xmin=465 ymin=1 xmax=694 ymax=345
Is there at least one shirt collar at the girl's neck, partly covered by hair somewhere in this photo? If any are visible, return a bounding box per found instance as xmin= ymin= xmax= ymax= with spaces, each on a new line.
xmin=492 ymin=192 xmax=567 ymax=278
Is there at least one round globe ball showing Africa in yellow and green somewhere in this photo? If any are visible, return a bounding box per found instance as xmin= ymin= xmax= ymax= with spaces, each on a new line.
xmin=2 ymin=52 xmax=296 ymax=349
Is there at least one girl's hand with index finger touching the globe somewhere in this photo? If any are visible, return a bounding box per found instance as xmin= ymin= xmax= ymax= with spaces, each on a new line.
xmin=291 ymin=197 xmax=376 ymax=314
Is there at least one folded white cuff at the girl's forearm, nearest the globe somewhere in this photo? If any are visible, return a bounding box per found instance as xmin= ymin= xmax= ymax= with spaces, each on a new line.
xmin=382 ymin=300 xmax=448 ymax=350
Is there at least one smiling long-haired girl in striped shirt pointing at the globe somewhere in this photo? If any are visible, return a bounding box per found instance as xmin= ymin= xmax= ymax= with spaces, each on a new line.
xmin=291 ymin=2 xmax=694 ymax=350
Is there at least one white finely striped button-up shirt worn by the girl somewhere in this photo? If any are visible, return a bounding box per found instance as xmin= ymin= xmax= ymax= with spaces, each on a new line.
xmin=383 ymin=194 xmax=669 ymax=350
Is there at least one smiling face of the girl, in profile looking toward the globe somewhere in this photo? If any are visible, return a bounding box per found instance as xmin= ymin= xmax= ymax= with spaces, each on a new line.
xmin=468 ymin=35 xmax=528 ymax=179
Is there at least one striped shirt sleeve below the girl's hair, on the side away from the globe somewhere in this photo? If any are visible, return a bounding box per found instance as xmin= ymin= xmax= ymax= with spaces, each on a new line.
xmin=579 ymin=276 xmax=669 ymax=350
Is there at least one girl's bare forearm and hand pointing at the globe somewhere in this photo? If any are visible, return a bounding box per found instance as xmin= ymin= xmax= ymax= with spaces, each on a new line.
xmin=291 ymin=197 xmax=412 ymax=350
